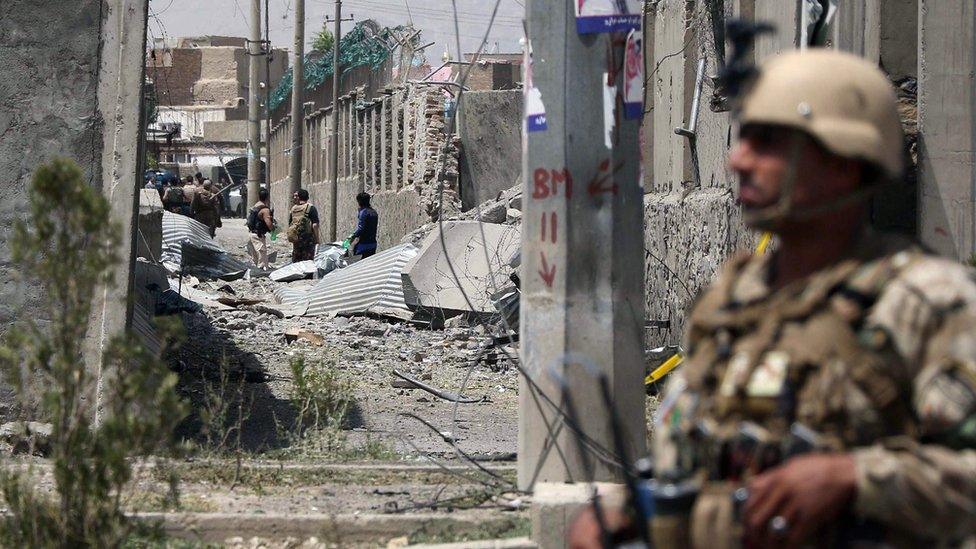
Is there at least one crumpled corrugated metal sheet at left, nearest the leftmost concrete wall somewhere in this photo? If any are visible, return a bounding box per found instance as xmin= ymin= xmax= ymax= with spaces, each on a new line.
xmin=160 ymin=212 xmax=248 ymax=278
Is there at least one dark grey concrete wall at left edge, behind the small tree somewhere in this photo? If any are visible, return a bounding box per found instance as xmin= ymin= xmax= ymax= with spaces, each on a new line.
xmin=0 ymin=0 xmax=102 ymax=331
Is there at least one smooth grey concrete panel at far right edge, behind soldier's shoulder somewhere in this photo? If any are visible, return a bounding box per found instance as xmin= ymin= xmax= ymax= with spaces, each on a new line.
xmin=918 ymin=0 xmax=976 ymax=260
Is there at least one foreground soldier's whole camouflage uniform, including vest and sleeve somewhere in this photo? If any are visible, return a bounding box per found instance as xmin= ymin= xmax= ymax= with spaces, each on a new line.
xmin=654 ymin=231 xmax=976 ymax=545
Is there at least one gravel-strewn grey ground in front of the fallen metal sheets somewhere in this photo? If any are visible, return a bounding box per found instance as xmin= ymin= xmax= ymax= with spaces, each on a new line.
xmin=180 ymin=219 xmax=518 ymax=460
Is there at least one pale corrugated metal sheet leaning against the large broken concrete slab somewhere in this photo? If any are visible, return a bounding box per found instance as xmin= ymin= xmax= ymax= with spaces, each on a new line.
xmin=275 ymin=244 xmax=418 ymax=316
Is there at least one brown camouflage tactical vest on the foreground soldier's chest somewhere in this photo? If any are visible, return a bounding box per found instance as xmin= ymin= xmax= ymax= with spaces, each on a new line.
xmin=655 ymin=242 xmax=922 ymax=549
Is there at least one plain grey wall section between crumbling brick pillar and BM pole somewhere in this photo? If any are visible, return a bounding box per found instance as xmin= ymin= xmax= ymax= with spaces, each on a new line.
xmin=458 ymin=90 xmax=523 ymax=210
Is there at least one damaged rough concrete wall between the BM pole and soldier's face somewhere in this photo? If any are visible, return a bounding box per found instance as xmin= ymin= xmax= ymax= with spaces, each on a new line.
xmin=642 ymin=0 xmax=901 ymax=346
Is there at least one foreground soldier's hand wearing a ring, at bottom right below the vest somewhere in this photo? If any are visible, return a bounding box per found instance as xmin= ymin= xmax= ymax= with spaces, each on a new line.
xmin=744 ymin=454 xmax=857 ymax=547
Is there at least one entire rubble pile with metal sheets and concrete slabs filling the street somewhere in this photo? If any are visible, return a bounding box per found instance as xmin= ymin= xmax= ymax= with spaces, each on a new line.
xmin=135 ymin=172 xmax=521 ymax=459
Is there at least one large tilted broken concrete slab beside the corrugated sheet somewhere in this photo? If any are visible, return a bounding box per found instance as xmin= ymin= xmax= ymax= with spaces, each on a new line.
xmin=403 ymin=221 xmax=521 ymax=313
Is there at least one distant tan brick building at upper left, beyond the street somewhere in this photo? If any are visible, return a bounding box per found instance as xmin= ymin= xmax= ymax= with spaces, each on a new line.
xmin=146 ymin=36 xmax=288 ymax=181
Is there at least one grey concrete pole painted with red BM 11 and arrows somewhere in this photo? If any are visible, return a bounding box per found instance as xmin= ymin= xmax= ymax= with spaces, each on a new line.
xmin=518 ymin=0 xmax=646 ymax=489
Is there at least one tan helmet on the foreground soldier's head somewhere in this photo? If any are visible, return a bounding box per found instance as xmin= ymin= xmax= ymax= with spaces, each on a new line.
xmin=739 ymin=48 xmax=904 ymax=180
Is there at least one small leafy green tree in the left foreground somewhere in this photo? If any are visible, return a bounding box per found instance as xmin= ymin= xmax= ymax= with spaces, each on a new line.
xmin=0 ymin=159 xmax=183 ymax=547
